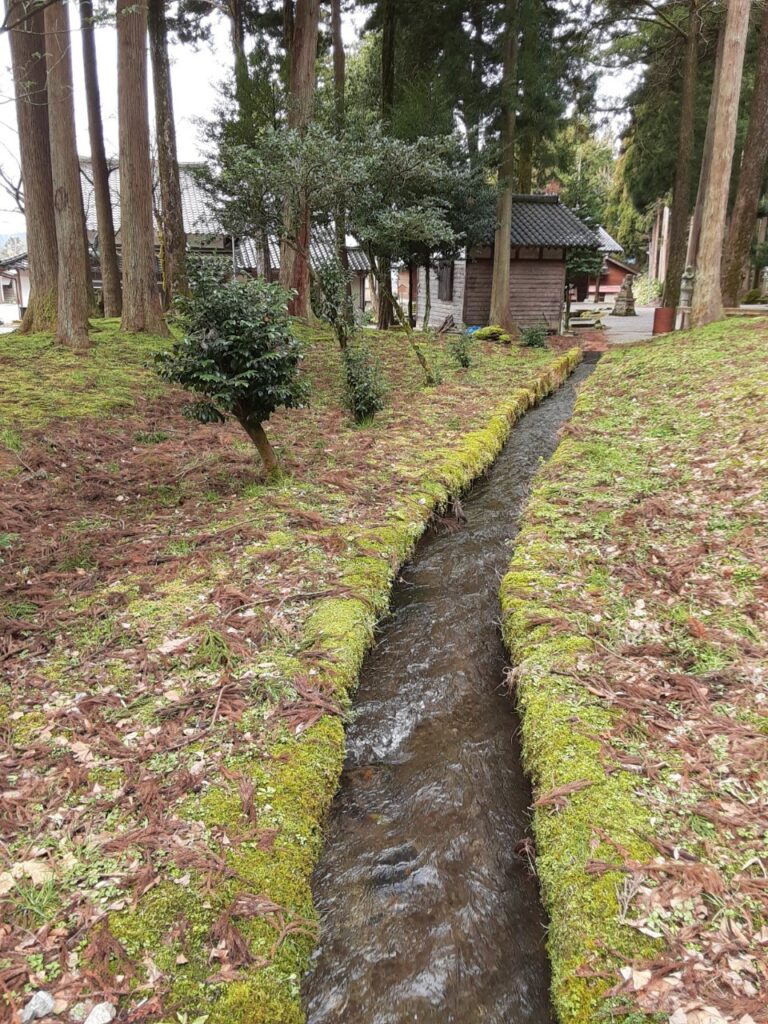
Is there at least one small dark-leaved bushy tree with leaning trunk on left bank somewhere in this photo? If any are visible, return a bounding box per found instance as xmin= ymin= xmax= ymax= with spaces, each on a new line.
xmin=156 ymin=257 xmax=307 ymax=475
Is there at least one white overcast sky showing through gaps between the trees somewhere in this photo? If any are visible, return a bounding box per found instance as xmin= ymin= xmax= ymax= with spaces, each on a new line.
xmin=0 ymin=3 xmax=627 ymax=234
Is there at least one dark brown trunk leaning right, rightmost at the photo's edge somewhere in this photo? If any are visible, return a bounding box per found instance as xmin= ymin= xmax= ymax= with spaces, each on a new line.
xmin=723 ymin=4 xmax=768 ymax=306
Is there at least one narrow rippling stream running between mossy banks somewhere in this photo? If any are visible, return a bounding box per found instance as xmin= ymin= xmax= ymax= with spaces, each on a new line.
xmin=304 ymin=356 xmax=594 ymax=1024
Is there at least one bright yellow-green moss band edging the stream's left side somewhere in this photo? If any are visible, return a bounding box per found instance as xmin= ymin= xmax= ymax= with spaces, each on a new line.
xmin=103 ymin=352 xmax=579 ymax=1024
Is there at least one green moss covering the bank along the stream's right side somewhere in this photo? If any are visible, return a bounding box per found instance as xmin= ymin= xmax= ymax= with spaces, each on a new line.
xmin=501 ymin=323 xmax=764 ymax=1024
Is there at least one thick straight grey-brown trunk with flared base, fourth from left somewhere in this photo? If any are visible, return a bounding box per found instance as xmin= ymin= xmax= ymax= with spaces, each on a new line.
xmin=118 ymin=0 xmax=168 ymax=335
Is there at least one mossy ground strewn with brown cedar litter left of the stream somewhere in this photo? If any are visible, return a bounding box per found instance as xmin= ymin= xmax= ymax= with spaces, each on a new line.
xmin=0 ymin=323 xmax=579 ymax=1024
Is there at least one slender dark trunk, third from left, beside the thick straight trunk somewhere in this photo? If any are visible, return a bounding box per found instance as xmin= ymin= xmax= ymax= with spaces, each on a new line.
xmin=80 ymin=0 xmax=122 ymax=316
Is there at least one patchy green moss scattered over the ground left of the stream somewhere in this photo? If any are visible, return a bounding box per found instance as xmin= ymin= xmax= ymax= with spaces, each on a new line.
xmin=6 ymin=325 xmax=579 ymax=1024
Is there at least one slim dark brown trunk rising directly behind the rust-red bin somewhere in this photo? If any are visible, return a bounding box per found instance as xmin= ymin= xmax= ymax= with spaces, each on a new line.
xmin=662 ymin=0 xmax=701 ymax=308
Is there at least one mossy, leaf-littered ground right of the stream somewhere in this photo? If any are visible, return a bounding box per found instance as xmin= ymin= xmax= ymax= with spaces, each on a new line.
xmin=502 ymin=321 xmax=768 ymax=1024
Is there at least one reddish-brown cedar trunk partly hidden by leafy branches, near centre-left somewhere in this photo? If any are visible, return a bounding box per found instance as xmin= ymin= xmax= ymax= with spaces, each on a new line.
xmin=280 ymin=0 xmax=319 ymax=319
